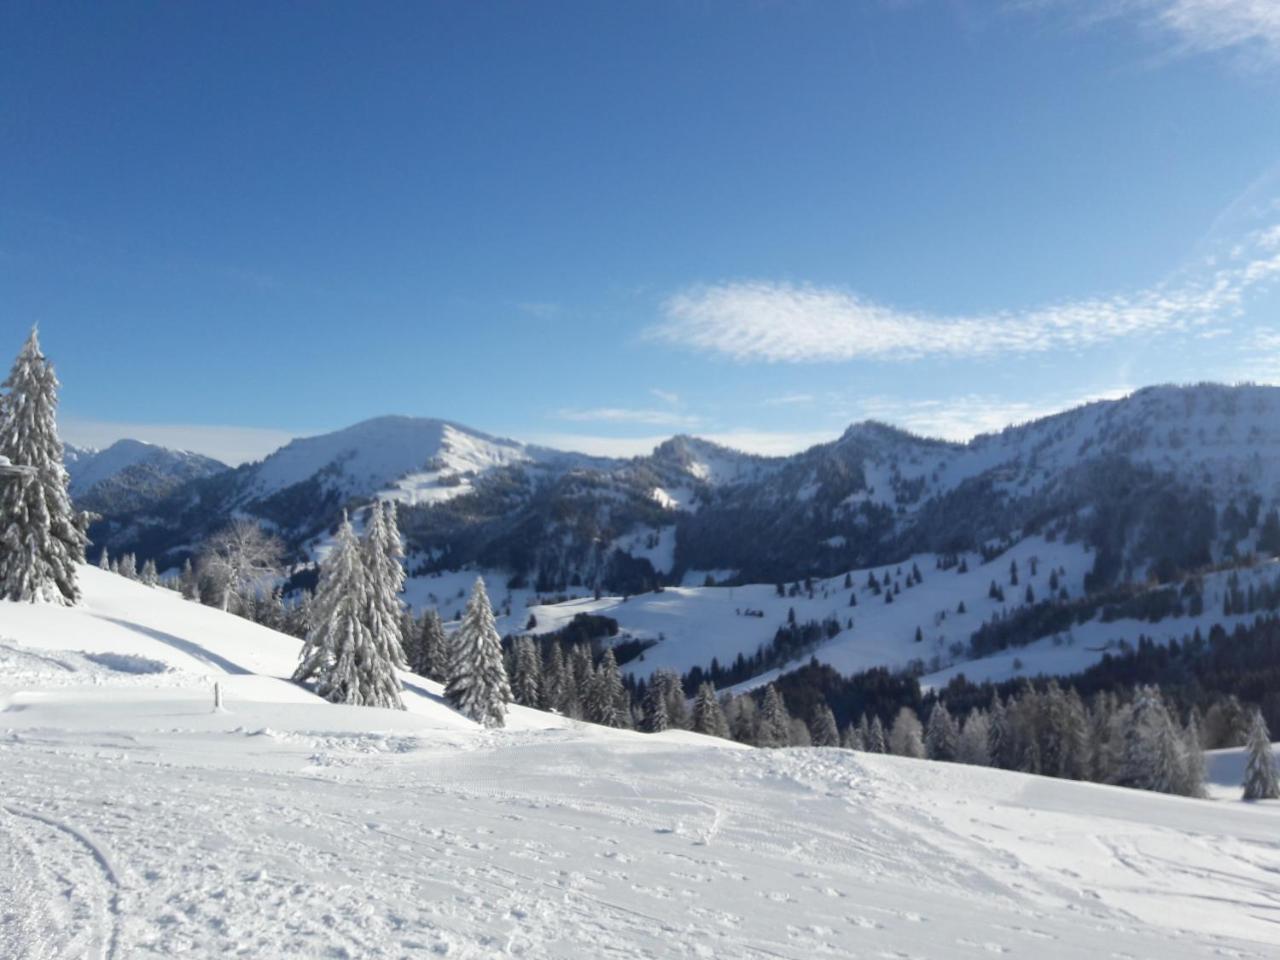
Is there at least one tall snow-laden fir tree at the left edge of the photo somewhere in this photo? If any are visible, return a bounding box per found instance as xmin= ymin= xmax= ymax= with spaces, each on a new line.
xmin=0 ymin=329 xmax=88 ymax=605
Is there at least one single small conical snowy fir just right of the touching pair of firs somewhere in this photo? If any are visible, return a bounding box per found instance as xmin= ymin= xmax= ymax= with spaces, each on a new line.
xmin=444 ymin=577 xmax=511 ymax=727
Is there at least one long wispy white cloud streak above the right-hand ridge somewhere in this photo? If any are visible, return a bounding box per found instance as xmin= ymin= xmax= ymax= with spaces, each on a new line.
xmin=648 ymin=228 xmax=1280 ymax=362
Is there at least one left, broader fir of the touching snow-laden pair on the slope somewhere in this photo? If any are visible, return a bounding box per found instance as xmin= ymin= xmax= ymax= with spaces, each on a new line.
xmin=293 ymin=516 xmax=404 ymax=709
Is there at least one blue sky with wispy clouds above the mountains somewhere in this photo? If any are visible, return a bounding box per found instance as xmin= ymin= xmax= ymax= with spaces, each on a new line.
xmin=0 ymin=0 xmax=1280 ymax=460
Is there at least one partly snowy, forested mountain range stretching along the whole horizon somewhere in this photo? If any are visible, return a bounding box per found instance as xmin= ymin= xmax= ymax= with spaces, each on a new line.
xmin=68 ymin=384 xmax=1280 ymax=593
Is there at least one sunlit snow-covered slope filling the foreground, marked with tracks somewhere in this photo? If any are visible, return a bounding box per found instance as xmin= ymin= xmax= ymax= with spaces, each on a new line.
xmin=0 ymin=570 xmax=1280 ymax=960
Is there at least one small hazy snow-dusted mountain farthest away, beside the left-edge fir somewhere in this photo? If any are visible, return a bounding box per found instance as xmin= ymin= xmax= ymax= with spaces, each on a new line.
xmin=63 ymin=440 xmax=229 ymax=513
